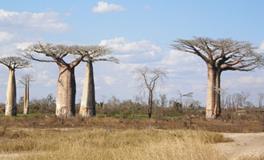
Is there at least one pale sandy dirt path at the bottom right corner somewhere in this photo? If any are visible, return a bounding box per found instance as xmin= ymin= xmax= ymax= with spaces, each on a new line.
xmin=216 ymin=133 xmax=264 ymax=160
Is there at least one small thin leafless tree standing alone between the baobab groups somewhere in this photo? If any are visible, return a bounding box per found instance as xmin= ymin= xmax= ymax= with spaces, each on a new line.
xmin=136 ymin=67 xmax=166 ymax=118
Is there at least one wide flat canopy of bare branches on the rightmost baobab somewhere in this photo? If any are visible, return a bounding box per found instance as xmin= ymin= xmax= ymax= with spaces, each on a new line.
xmin=172 ymin=37 xmax=261 ymax=71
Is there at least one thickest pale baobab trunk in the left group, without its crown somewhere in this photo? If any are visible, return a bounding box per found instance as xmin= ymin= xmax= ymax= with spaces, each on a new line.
xmin=56 ymin=66 xmax=76 ymax=118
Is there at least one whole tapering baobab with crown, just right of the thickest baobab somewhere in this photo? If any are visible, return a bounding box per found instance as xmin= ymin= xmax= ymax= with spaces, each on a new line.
xmin=79 ymin=46 xmax=118 ymax=117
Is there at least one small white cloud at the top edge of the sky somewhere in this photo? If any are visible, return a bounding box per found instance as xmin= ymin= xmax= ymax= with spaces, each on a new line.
xmin=92 ymin=1 xmax=125 ymax=13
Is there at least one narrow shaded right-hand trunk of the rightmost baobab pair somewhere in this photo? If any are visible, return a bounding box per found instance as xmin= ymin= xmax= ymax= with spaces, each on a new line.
xmin=215 ymin=71 xmax=221 ymax=117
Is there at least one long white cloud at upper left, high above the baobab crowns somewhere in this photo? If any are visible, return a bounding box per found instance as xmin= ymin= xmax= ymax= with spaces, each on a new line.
xmin=0 ymin=9 xmax=68 ymax=32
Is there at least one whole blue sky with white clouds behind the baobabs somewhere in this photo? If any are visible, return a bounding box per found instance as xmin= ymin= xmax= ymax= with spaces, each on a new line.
xmin=0 ymin=0 xmax=264 ymax=102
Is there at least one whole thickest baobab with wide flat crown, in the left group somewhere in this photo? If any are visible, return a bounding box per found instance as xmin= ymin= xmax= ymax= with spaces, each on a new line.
xmin=25 ymin=43 xmax=102 ymax=117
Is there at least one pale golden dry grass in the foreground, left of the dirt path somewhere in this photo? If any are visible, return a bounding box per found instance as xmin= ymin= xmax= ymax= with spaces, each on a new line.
xmin=0 ymin=128 xmax=228 ymax=160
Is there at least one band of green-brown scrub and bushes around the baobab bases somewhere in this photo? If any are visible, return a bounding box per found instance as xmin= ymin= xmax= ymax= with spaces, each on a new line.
xmin=0 ymin=95 xmax=264 ymax=132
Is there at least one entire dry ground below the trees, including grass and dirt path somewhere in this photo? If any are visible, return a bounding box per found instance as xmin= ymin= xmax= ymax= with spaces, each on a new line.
xmin=0 ymin=110 xmax=264 ymax=160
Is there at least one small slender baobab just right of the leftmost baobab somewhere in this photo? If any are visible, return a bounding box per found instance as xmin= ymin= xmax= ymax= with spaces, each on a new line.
xmin=19 ymin=74 xmax=33 ymax=115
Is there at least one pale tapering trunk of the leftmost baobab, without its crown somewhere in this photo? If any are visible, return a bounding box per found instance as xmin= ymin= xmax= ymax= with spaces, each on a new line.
xmin=5 ymin=69 xmax=17 ymax=116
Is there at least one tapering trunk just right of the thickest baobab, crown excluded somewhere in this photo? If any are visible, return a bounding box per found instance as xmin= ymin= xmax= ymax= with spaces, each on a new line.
xmin=79 ymin=62 xmax=96 ymax=117
